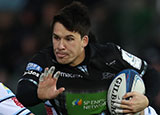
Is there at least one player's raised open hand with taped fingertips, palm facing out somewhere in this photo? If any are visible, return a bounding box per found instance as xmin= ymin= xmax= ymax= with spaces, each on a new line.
xmin=37 ymin=66 xmax=65 ymax=100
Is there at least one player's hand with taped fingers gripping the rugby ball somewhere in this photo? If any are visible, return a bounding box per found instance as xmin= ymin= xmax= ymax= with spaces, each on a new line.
xmin=114 ymin=91 xmax=149 ymax=114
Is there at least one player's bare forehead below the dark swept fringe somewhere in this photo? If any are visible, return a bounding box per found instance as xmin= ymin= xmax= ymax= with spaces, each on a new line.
xmin=53 ymin=22 xmax=80 ymax=37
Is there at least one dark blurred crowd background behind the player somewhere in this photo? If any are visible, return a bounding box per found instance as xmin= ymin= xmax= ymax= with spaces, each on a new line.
xmin=0 ymin=0 xmax=160 ymax=115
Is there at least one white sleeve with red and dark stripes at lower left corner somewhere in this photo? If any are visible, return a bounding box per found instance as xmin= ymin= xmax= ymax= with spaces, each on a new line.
xmin=0 ymin=83 xmax=31 ymax=115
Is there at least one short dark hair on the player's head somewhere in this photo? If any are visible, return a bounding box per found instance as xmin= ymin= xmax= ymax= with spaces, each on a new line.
xmin=52 ymin=1 xmax=91 ymax=37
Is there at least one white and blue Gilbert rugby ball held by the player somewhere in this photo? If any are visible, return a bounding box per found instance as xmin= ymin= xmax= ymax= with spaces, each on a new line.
xmin=107 ymin=69 xmax=145 ymax=115
